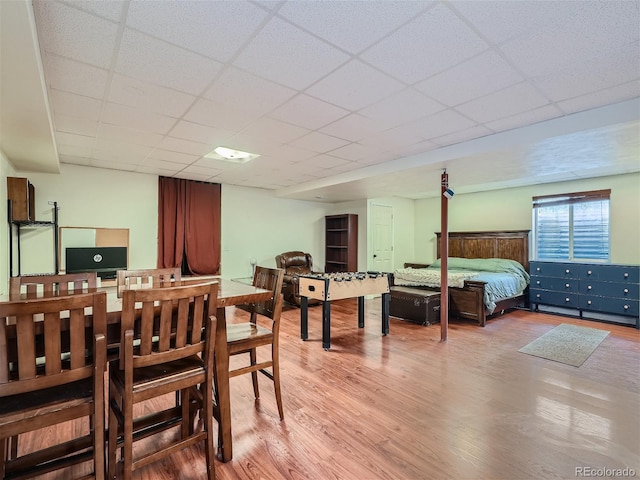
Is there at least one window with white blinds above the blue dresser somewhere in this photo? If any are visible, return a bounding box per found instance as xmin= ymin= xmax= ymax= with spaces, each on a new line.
xmin=533 ymin=190 xmax=611 ymax=261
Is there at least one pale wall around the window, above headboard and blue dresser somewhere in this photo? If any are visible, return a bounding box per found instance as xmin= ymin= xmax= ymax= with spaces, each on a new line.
xmin=414 ymin=173 xmax=640 ymax=264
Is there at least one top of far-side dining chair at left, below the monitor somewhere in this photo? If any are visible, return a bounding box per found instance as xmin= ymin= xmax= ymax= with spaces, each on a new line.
xmin=9 ymin=272 xmax=98 ymax=300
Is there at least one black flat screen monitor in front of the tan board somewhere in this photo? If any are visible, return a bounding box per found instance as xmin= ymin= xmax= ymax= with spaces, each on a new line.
xmin=65 ymin=247 xmax=127 ymax=280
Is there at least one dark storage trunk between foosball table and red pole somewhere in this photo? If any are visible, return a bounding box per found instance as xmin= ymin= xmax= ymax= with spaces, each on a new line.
xmin=389 ymin=286 xmax=440 ymax=325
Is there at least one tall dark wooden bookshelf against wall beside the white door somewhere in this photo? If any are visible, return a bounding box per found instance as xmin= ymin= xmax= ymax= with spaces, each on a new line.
xmin=324 ymin=213 xmax=358 ymax=273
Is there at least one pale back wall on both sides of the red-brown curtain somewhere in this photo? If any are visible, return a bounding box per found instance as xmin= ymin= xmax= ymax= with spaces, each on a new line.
xmin=8 ymin=165 xmax=327 ymax=278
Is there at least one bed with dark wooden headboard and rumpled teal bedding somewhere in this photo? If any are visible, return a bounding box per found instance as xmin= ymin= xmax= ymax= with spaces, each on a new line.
xmin=394 ymin=230 xmax=529 ymax=327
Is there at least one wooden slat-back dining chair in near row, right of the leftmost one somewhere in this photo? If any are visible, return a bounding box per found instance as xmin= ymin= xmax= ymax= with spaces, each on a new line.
xmin=108 ymin=282 xmax=218 ymax=480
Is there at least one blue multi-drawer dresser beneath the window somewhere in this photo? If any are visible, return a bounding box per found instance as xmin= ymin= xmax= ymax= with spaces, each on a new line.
xmin=529 ymin=261 xmax=640 ymax=328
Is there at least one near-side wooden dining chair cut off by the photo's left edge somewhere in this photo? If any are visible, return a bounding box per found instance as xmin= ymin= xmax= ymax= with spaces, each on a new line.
xmin=0 ymin=292 xmax=107 ymax=479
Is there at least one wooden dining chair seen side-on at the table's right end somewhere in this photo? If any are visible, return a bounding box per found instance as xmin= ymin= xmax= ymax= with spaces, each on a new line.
xmin=227 ymin=266 xmax=284 ymax=420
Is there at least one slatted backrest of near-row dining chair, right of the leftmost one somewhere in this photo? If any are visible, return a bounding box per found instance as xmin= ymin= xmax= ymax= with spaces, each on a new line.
xmin=120 ymin=282 xmax=218 ymax=369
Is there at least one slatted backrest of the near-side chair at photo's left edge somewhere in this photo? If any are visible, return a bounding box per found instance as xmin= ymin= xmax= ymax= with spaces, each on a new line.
xmin=0 ymin=292 xmax=107 ymax=397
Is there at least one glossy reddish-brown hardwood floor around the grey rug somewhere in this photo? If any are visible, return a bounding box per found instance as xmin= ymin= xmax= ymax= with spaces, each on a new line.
xmin=12 ymin=300 xmax=640 ymax=480
